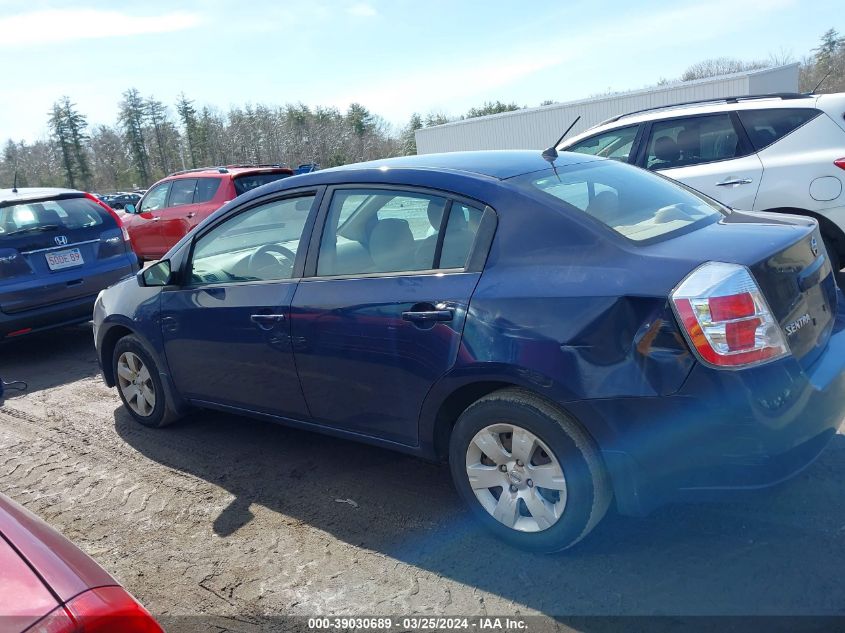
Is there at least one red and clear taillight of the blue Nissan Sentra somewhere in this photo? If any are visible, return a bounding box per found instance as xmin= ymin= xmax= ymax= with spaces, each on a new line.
xmin=671 ymin=262 xmax=790 ymax=368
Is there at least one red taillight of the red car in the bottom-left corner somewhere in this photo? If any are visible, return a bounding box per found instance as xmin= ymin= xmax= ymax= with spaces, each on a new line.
xmin=27 ymin=587 xmax=164 ymax=633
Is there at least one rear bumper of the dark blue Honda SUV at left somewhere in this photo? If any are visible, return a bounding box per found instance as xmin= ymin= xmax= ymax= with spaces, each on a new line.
xmin=0 ymin=255 xmax=137 ymax=341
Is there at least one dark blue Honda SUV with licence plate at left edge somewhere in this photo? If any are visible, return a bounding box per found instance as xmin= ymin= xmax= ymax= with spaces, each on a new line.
xmin=0 ymin=188 xmax=138 ymax=341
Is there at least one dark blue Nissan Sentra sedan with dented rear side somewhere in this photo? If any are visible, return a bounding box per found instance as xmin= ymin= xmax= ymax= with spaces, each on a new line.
xmin=94 ymin=151 xmax=845 ymax=552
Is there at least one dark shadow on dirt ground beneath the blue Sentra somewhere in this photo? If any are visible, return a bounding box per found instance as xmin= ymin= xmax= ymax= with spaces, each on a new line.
xmin=115 ymin=408 xmax=845 ymax=616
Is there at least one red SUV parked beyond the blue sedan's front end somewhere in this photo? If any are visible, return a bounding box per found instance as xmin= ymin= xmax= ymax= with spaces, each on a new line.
xmin=124 ymin=165 xmax=293 ymax=260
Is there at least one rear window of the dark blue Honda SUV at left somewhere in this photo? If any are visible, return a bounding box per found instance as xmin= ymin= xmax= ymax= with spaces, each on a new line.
xmin=0 ymin=198 xmax=110 ymax=239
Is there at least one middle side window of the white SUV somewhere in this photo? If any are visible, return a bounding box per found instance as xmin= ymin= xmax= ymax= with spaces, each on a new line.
xmin=645 ymin=113 xmax=749 ymax=170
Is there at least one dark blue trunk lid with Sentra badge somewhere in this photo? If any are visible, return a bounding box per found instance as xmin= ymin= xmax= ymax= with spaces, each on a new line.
xmin=648 ymin=211 xmax=837 ymax=367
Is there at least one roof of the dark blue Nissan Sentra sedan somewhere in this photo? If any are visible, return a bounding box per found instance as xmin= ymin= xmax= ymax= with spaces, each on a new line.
xmin=316 ymin=149 xmax=601 ymax=180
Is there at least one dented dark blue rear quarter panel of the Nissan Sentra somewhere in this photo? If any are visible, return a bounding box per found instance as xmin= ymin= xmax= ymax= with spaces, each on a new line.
xmin=421 ymin=185 xmax=695 ymax=452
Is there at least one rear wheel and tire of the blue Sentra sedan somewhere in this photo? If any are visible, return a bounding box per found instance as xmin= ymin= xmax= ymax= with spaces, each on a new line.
xmin=449 ymin=389 xmax=612 ymax=553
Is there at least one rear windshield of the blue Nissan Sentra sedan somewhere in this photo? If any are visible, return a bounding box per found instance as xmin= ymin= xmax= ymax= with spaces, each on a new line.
xmin=517 ymin=160 xmax=724 ymax=242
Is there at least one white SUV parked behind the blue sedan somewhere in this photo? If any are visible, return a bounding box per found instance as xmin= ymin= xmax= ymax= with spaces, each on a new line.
xmin=558 ymin=93 xmax=845 ymax=270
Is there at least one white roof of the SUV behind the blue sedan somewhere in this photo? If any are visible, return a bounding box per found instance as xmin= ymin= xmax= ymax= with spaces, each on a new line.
xmin=561 ymin=94 xmax=818 ymax=147
